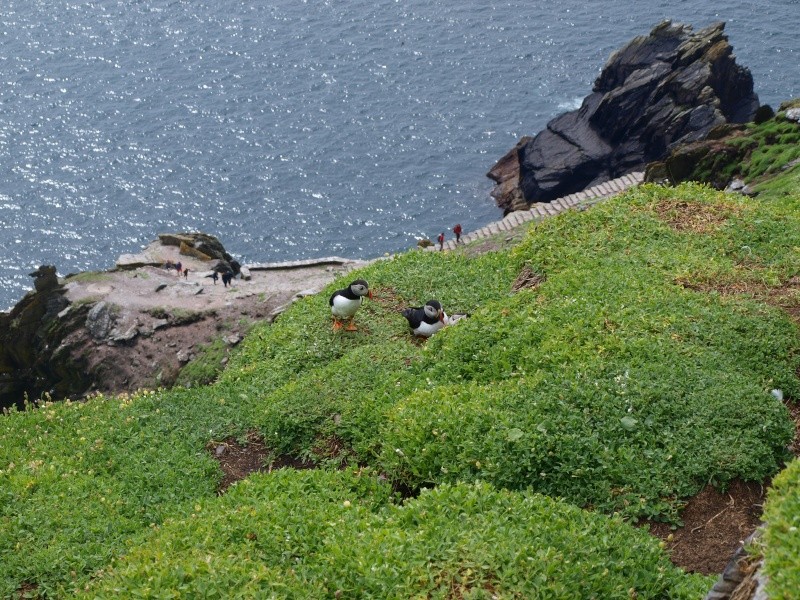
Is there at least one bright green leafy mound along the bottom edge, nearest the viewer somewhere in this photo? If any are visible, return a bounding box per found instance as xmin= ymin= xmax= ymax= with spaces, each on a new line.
xmin=79 ymin=471 xmax=709 ymax=598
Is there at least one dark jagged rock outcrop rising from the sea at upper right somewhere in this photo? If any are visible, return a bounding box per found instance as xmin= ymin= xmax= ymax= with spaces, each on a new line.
xmin=488 ymin=21 xmax=759 ymax=213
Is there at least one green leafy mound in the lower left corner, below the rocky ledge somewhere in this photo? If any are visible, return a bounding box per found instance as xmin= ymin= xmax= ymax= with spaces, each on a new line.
xmin=0 ymin=391 xmax=252 ymax=598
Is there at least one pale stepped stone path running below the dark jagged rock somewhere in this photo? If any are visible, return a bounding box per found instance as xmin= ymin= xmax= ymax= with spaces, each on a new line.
xmin=426 ymin=171 xmax=644 ymax=251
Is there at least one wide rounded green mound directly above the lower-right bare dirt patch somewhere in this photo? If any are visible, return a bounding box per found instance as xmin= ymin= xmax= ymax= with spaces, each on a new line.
xmin=381 ymin=364 xmax=792 ymax=521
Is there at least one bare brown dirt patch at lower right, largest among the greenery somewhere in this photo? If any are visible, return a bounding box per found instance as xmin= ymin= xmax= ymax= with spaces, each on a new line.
xmin=649 ymin=480 xmax=767 ymax=575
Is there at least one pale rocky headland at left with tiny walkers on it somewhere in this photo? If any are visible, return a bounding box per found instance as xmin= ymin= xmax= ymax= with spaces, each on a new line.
xmin=0 ymin=233 xmax=365 ymax=408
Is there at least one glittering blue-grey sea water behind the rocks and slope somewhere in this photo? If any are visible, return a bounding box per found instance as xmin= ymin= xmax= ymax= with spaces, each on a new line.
xmin=0 ymin=0 xmax=800 ymax=309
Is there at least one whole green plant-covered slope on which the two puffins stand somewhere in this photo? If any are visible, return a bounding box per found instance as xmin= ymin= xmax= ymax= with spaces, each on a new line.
xmin=0 ymin=173 xmax=800 ymax=598
